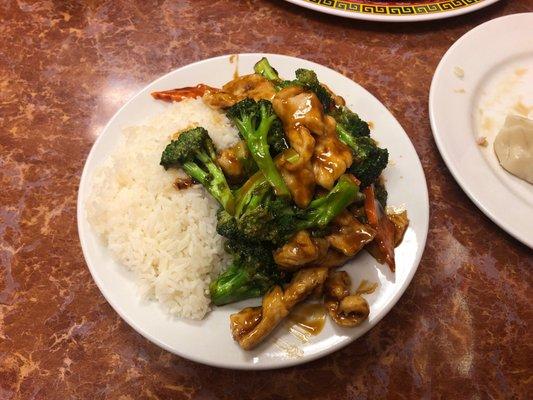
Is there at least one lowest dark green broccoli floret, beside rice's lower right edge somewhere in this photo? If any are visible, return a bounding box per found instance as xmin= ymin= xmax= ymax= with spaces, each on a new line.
xmin=209 ymin=240 xmax=287 ymax=305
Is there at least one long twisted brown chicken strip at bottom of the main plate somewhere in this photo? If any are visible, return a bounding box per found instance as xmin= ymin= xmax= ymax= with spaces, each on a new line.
xmin=230 ymin=268 xmax=328 ymax=350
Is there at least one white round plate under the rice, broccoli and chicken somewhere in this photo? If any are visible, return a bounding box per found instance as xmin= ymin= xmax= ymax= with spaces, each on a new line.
xmin=78 ymin=54 xmax=429 ymax=369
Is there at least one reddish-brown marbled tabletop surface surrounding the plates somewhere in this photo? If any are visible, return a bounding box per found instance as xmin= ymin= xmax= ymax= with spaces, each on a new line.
xmin=0 ymin=0 xmax=533 ymax=400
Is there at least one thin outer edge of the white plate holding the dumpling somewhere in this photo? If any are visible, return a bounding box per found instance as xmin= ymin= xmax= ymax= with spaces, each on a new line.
xmin=428 ymin=13 xmax=533 ymax=249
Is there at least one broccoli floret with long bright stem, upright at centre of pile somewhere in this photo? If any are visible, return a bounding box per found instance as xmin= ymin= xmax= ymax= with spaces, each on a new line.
xmin=227 ymin=99 xmax=290 ymax=197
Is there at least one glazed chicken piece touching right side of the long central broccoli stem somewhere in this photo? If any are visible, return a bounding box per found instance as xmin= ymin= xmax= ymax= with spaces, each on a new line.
xmin=276 ymin=155 xmax=315 ymax=208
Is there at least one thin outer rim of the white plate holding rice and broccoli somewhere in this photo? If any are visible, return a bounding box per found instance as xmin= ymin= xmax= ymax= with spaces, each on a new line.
xmin=76 ymin=53 xmax=431 ymax=370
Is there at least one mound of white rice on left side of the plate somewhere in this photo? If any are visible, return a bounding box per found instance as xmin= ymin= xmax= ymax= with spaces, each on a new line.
xmin=86 ymin=99 xmax=238 ymax=319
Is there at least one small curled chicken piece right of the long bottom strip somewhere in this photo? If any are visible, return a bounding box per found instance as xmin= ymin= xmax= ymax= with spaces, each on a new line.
xmin=324 ymin=271 xmax=370 ymax=327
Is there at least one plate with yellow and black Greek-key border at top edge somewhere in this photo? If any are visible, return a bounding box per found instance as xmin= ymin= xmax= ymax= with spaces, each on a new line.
xmin=286 ymin=0 xmax=499 ymax=22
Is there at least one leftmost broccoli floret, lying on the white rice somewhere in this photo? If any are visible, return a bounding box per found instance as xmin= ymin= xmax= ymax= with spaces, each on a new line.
xmin=160 ymin=127 xmax=235 ymax=212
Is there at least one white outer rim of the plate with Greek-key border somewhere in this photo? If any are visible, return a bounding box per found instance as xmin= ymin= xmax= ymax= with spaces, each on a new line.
xmin=285 ymin=0 xmax=500 ymax=22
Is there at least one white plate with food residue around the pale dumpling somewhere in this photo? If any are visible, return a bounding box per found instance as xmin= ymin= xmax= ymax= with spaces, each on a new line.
xmin=429 ymin=13 xmax=533 ymax=247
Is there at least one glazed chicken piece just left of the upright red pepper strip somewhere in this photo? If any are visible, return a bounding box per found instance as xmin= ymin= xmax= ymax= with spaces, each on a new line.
xmin=326 ymin=211 xmax=376 ymax=257
